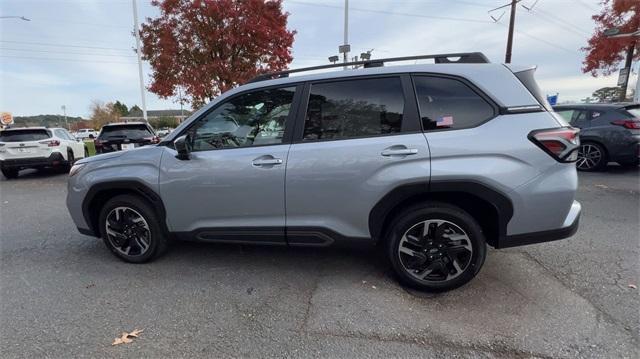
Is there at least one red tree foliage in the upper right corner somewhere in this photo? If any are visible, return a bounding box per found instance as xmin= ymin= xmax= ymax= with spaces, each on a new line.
xmin=582 ymin=0 xmax=640 ymax=82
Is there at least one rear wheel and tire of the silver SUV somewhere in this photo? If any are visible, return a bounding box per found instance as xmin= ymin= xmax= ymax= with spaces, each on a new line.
xmin=386 ymin=202 xmax=487 ymax=292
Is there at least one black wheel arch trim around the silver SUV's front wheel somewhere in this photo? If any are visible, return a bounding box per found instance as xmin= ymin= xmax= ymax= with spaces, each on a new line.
xmin=82 ymin=180 xmax=169 ymax=237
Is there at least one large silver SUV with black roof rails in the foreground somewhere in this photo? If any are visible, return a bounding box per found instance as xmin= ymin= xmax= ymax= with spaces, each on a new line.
xmin=67 ymin=53 xmax=580 ymax=291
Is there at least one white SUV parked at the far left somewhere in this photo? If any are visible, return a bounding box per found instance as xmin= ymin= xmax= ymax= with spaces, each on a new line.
xmin=0 ymin=127 xmax=88 ymax=179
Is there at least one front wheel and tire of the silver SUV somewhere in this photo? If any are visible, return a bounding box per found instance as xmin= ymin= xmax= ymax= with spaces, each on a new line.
xmin=98 ymin=195 xmax=168 ymax=263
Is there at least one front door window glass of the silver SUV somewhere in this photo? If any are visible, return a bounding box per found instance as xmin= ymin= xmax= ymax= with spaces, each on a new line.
xmin=187 ymin=87 xmax=295 ymax=151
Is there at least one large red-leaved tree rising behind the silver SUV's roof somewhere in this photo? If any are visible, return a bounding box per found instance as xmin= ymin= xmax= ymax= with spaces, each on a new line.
xmin=140 ymin=0 xmax=295 ymax=107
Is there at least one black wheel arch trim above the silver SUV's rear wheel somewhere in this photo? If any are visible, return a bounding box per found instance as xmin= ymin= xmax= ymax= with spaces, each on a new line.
xmin=369 ymin=180 xmax=513 ymax=248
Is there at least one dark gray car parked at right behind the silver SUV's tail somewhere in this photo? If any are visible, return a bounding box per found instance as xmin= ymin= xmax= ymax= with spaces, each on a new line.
xmin=554 ymin=103 xmax=640 ymax=171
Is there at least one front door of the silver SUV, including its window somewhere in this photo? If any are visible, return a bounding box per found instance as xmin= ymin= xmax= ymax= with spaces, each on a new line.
xmin=160 ymin=87 xmax=296 ymax=244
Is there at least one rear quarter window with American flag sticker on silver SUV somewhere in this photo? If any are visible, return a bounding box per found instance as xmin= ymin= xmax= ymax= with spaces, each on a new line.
xmin=413 ymin=76 xmax=495 ymax=130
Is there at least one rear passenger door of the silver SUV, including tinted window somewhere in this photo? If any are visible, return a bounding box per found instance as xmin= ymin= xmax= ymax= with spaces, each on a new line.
xmin=286 ymin=75 xmax=430 ymax=245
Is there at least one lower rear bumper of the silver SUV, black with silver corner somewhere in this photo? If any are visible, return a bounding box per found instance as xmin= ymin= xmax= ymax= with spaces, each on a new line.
xmin=498 ymin=201 xmax=582 ymax=248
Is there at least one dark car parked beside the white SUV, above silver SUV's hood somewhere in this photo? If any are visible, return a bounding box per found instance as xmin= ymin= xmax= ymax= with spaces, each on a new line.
xmin=95 ymin=122 xmax=160 ymax=153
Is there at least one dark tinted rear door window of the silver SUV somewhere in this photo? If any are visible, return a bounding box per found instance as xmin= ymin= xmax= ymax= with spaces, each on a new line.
xmin=303 ymin=77 xmax=404 ymax=141
